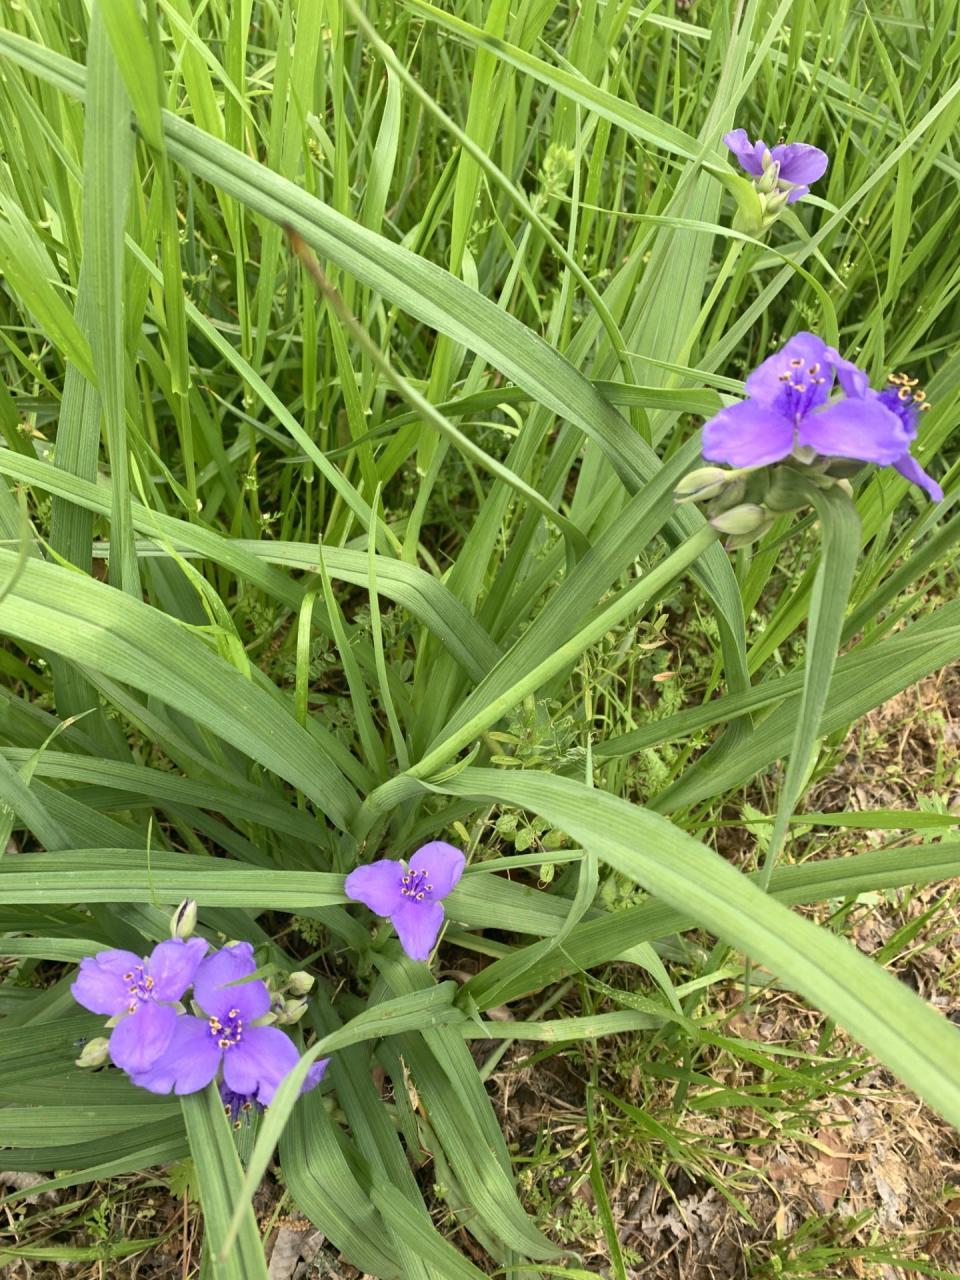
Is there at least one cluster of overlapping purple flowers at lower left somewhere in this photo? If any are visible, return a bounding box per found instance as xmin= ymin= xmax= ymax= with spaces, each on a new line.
xmin=70 ymin=938 xmax=328 ymax=1119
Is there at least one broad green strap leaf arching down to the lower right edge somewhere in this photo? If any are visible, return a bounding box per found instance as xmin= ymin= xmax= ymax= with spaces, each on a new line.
xmin=431 ymin=768 xmax=960 ymax=1125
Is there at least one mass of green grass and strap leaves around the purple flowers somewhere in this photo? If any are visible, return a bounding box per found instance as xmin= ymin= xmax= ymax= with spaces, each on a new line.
xmin=0 ymin=0 xmax=960 ymax=1280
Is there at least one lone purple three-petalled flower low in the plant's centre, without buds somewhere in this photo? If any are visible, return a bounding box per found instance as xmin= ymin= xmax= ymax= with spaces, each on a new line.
xmin=343 ymin=840 xmax=466 ymax=960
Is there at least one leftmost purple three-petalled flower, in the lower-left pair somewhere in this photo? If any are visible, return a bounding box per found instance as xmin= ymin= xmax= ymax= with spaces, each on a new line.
xmin=70 ymin=938 xmax=207 ymax=1074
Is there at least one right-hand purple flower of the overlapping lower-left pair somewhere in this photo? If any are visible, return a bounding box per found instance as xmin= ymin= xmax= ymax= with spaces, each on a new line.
xmin=131 ymin=942 xmax=328 ymax=1107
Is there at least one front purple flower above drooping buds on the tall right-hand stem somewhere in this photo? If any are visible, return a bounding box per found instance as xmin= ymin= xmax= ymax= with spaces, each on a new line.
xmin=703 ymin=333 xmax=911 ymax=467
